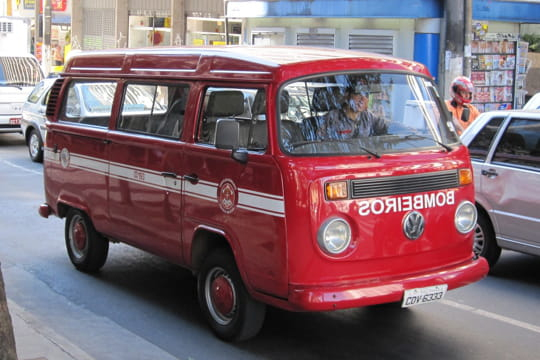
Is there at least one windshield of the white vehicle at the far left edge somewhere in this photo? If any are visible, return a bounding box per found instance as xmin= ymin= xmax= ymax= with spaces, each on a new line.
xmin=0 ymin=56 xmax=43 ymax=87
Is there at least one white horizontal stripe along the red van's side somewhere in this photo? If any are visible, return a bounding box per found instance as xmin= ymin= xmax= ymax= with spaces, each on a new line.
xmin=45 ymin=148 xmax=285 ymax=217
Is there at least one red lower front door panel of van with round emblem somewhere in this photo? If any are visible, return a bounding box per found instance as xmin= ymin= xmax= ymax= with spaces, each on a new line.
xmin=184 ymin=145 xmax=288 ymax=297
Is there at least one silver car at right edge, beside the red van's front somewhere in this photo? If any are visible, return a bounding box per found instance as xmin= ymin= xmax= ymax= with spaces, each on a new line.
xmin=461 ymin=110 xmax=540 ymax=266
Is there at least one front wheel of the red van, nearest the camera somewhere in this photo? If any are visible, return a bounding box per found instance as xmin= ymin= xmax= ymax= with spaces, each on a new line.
xmin=197 ymin=249 xmax=266 ymax=341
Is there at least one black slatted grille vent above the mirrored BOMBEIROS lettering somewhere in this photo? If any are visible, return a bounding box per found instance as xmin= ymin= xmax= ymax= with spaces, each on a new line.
xmin=351 ymin=170 xmax=459 ymax=199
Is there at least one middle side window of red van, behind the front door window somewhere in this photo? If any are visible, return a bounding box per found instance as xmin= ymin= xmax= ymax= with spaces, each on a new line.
xmin=118 ymin=84 xmax=189 ymax=139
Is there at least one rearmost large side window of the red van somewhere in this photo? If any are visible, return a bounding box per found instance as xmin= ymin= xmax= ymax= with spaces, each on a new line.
xmin=61 ymin=80 xmax=116 ymax=127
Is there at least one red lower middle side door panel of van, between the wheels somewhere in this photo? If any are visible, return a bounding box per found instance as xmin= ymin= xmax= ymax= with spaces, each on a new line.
xmin=106 ymin=131 xmax=183 ymax=262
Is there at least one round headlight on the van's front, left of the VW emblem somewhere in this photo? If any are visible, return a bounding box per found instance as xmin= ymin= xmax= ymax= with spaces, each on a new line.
xmin=317 ymin=218 xmax=351 ymax=255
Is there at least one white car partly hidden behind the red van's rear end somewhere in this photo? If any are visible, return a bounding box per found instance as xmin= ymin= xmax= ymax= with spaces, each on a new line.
xmin=21 ymin=78 xmax=56 ymax=162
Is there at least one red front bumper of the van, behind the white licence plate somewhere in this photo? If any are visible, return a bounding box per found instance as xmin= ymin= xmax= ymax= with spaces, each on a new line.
xmin=288 ymin=257 xmax=489 ymax=311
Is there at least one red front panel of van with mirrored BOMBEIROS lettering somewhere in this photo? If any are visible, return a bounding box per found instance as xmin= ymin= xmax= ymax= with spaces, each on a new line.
xmin=280 ymin=149 xmax=474 ymax=285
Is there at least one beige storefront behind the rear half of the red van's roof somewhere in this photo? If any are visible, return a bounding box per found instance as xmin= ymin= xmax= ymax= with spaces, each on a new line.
xmin=73 ymin=0 xmax=242 ymax=50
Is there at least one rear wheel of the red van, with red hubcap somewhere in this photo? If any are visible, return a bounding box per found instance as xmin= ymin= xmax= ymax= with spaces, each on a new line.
xmin=65 ymin=209 xmax=109 ymax=272
